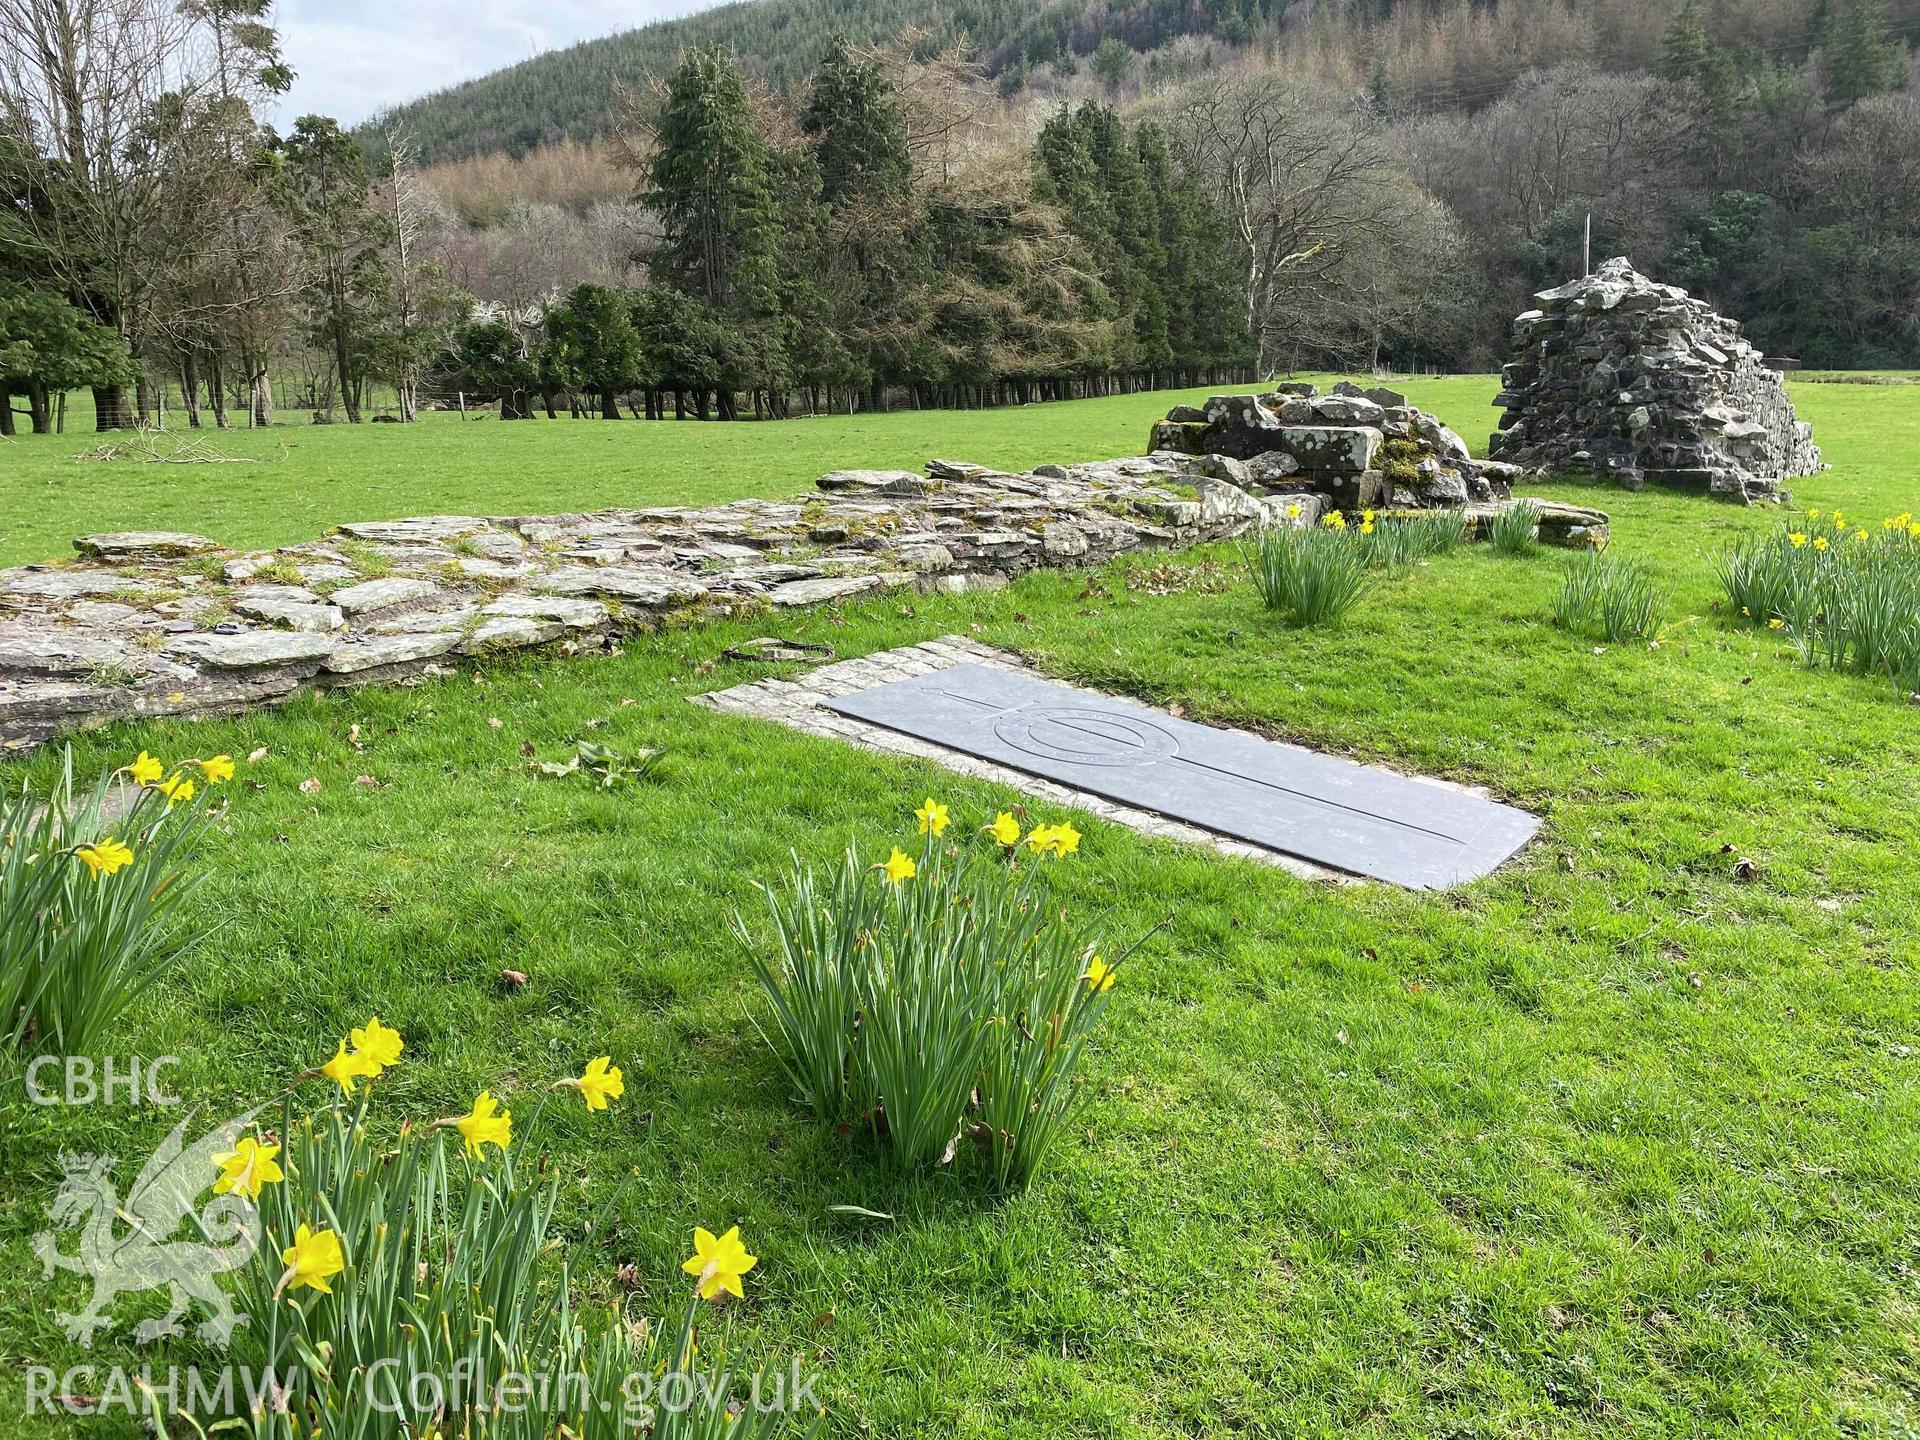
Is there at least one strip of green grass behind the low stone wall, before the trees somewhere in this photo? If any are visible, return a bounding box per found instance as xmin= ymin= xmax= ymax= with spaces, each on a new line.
xmin=0 ymin=378 xmax=1494 ymax=564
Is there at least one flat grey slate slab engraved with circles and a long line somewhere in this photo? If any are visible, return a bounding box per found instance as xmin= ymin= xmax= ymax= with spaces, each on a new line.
xmin=826 ymin=664 xmax=1540 ymax=889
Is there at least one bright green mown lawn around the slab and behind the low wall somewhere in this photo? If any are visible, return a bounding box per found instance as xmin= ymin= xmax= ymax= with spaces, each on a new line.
xmin=0 ymin=380 xmax=1920 ymax=1438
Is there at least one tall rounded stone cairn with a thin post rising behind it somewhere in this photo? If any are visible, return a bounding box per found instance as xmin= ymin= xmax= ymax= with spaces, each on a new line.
xmin=1490 ymin=259 xmax=1820 ymax=503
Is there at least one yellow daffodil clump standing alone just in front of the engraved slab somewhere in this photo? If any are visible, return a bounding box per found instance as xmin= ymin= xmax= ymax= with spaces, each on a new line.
xmin=735 ymin=797 xmax=1119 ymax=1188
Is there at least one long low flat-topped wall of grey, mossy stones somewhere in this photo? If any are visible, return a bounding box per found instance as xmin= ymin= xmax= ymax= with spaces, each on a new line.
xmin=0 ymin=453 xmax=1605 ymax=753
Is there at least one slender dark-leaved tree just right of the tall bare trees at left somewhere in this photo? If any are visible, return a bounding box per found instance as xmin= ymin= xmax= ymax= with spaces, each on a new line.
xmin=282 ymin=115 xmax=392 ymax=424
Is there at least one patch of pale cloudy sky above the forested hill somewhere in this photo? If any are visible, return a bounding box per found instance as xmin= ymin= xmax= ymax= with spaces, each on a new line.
xmin=273 ymin=0 xmax=716 ymax=129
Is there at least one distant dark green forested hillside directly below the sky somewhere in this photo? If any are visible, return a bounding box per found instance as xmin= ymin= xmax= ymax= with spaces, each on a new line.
xmin=361 ymin=0 xmax=1288 ymax=163
